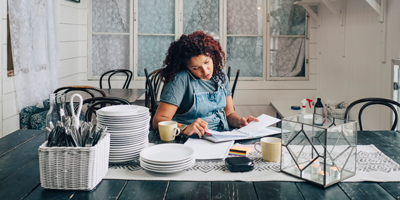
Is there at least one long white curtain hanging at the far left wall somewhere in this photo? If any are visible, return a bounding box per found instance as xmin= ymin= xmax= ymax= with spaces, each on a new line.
xmin=8 ymin=0 xmax=58 ymax=110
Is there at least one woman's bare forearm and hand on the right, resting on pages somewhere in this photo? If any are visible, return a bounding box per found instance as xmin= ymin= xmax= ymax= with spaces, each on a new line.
xmin=224 ymin=96 xmax=258 ymax=128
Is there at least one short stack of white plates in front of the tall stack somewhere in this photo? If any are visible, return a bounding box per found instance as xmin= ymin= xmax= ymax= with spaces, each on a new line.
xmin=140 ymin=144 xmax=195 ymax=173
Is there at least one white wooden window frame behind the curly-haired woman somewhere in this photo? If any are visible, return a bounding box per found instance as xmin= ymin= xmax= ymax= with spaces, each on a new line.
xmin=87 ymin=0 xmax=310 ymax=81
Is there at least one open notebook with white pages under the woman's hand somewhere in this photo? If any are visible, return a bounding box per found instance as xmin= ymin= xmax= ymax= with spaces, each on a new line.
xmin=203 ymin=114 xmax=281 ymax=142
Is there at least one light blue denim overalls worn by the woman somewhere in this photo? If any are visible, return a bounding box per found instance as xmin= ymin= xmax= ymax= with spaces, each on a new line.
xmin=172 ymin=72 xmax=229 ymax=131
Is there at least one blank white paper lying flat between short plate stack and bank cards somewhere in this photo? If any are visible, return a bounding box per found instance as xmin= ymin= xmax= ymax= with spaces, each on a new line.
xmin=185 ymin=138 xmax=233 ymax=160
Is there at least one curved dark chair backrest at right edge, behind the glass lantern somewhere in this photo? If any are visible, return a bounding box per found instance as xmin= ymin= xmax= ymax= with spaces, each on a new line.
xmin=344 ymin=97 xmax=400 ymax=131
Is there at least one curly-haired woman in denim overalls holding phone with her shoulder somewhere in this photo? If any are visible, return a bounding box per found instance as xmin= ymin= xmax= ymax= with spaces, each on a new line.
xmin=153 ymin=31 xmax=258 ymax=138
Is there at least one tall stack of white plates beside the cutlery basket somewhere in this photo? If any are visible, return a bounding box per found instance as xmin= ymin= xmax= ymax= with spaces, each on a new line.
xmin=97 ymin=105 xmax=150 ymax=163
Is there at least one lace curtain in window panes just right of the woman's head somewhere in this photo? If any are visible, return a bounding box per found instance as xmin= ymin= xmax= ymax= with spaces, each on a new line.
xmin=226 ymin=0 xmax=265 ymax=77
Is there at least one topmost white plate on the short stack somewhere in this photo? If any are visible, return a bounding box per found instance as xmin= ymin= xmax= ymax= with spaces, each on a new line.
xmin=140 ymin=144 xmax=194 ymax=163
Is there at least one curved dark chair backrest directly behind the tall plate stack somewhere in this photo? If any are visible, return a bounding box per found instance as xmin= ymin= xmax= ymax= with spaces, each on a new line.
xmin=80 ymin=97 xmax=129 ymax=122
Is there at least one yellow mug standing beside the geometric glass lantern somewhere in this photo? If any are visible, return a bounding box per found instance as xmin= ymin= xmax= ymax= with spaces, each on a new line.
xmin=254 ymin=137 xmax=282 ymax=162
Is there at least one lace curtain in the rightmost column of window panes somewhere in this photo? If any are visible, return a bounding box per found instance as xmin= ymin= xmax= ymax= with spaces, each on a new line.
xmin=270 ymin=0 xmax=306 ymax=77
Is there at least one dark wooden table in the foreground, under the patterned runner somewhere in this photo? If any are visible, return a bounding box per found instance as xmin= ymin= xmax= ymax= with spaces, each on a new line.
xmin=0 ymin=130 xmax=400 ymax=200
